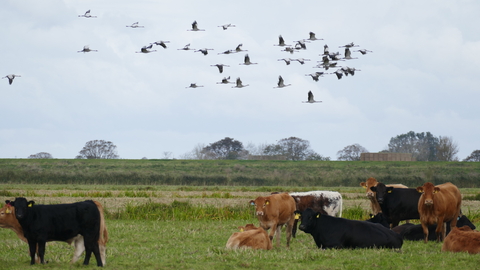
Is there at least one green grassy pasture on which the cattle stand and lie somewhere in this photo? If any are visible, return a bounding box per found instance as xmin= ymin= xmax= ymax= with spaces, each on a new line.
xmin=0 ymin=184 xmax=480 ymax=270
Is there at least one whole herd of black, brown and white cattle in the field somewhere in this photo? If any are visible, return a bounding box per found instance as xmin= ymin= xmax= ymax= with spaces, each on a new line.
xmin=0 ymin=178 xmax=480 ymax=266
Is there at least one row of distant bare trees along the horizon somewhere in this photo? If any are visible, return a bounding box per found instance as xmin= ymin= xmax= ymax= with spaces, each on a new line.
xmin=28 ymin=131 xmax=480 ymax=162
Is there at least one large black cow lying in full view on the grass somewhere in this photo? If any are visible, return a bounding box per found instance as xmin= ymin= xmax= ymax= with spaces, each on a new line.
xmin=297 ymin=208 xmax=403 ymax=249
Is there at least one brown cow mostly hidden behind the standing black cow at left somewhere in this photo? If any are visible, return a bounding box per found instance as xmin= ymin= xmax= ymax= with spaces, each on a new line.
xmin=0 ymin=201 xmax=108 ymax=266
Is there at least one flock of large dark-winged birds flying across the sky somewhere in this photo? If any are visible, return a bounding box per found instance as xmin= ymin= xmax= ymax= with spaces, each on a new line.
xmin=2 ymin=10 xmax=372 ymax=103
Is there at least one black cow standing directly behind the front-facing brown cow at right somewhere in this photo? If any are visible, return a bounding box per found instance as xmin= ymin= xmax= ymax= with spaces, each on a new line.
xmin=370 ymin=183 xmax=422 ymax=228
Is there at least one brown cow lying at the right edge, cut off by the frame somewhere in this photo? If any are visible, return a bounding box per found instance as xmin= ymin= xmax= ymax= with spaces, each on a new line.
xmin=442 ymin=225 xmax=480 ymax=254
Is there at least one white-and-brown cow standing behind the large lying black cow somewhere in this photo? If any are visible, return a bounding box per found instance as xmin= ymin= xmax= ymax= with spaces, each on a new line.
xmin=290 ymin=191 xmax=343 ymax=237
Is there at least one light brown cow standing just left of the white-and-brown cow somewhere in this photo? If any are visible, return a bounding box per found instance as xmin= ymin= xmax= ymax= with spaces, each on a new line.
xmin=250 ymin=193 xmax=295 ymax=247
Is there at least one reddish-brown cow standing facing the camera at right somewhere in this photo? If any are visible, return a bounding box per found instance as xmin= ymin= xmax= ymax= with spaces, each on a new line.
xmin=417 ymin=182 xmax=462 ymax=243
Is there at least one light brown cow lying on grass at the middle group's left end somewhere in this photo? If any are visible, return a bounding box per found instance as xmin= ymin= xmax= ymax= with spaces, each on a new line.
xmin=226 ymin=224 xmax=272 ymax=250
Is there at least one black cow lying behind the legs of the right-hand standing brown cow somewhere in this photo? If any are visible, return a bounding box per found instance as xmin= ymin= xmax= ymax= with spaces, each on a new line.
xmin=392 ymin=215 xmax=476 ymax=241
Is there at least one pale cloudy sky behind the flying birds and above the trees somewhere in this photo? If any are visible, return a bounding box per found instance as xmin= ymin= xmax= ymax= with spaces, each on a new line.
xmin=0 ymin=0 xmax=480 ymax=160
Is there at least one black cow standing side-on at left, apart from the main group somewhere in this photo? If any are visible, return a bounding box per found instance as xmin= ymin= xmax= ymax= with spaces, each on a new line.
xmin=6 ymin=198 xmax=103 ymax=266
